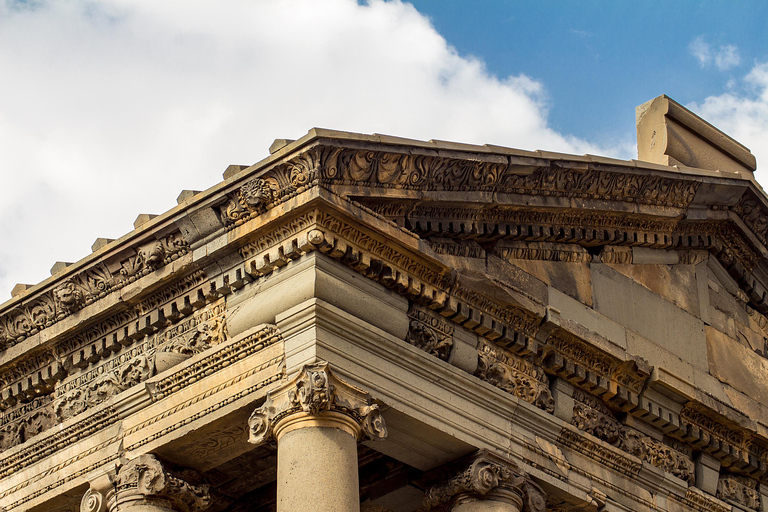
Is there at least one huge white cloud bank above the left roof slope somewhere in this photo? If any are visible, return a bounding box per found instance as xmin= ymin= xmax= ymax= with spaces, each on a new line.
xmin=0 ymin=0 xmax=631 ymax=297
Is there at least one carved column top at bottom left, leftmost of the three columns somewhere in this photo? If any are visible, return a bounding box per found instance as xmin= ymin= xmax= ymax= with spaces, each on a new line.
xmin=80 ymin=454 xmax=211 ymax=512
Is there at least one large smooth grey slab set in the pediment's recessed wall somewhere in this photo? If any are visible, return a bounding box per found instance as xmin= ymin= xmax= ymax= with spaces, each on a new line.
xmin=592 ymin=264 xmax=707 ymax=369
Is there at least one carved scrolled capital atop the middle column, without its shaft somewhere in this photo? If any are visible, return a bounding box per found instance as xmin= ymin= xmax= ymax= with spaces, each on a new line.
xmin=248 ymin=362 xmax=387 ymax=444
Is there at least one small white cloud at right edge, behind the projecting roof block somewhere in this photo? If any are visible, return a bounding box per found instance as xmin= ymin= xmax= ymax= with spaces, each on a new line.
xmin=689 ymin=62 xmax=768 ymax=176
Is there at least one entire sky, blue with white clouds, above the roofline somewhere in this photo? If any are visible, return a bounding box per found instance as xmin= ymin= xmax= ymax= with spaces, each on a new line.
xmin=0 ymin=0 xmax=768 ymax=301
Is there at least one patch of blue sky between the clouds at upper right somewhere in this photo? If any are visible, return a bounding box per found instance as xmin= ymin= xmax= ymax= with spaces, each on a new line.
xmin=412 ymin=0 xmax=768 ymax=148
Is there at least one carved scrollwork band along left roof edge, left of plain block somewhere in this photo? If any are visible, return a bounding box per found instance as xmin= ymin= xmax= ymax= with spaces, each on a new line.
xmin=0 ymin=234 xmax=188 ymax=348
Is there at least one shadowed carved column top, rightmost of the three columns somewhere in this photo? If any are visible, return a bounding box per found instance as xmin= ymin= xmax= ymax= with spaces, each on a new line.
xmin=424 ymin=450 xmax=546 ymax=512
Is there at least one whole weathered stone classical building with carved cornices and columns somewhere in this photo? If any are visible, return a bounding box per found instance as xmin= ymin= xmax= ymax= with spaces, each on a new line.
xmin=0 ymin=96 xmax=768 ymax=512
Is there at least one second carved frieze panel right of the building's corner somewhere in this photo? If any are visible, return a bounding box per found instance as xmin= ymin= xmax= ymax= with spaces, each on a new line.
xmin=475 ymin=341 xmax=555 ymax=413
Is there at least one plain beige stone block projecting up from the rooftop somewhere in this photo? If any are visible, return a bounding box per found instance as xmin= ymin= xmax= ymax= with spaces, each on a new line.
xmin=635 ymin=95 xmax=757 ymax=177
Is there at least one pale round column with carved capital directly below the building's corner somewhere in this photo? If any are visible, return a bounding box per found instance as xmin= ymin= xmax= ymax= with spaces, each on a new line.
xmin=248 ymin=363 xmax=387 ymax=512
